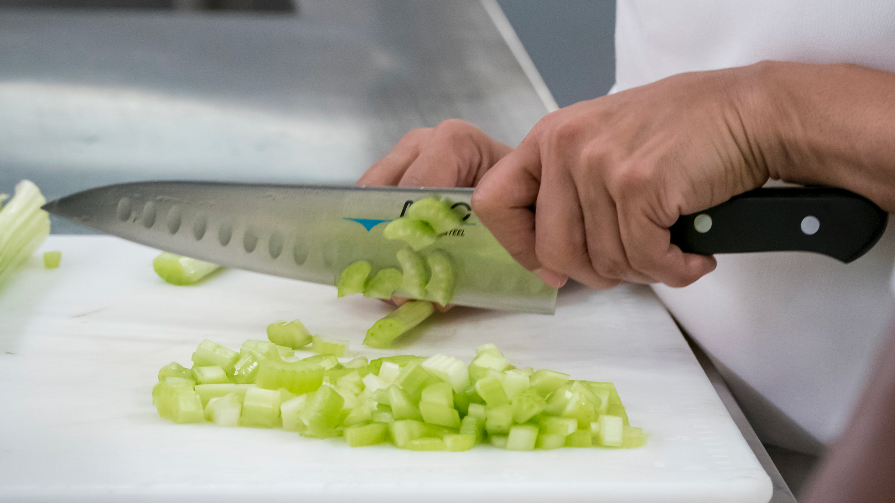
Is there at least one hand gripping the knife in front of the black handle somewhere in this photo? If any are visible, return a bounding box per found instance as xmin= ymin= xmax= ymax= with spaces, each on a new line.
xmin=472 ymin=67 xmax=769 ymax=288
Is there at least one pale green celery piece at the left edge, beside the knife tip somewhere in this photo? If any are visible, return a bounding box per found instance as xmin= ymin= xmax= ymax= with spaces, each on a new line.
xmin=0 ymin=180 xmax=50 ymax=285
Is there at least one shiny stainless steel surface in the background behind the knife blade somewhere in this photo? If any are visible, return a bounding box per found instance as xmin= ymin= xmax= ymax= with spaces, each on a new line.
xmin=0 ymin=0 xmax=549 ymax=233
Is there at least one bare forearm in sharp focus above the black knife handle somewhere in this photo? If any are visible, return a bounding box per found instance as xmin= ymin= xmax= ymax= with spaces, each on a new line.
xmin=746 ymin=62 xmax=895 ymax=212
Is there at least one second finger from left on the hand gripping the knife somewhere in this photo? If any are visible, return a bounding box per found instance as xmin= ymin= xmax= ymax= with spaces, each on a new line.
xmin=535 ymin=155 xmax=620 ymax=288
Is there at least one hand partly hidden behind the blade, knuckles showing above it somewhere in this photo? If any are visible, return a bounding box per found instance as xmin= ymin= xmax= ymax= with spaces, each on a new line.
xmin=357 ymin=119 xmax=512 ymax=187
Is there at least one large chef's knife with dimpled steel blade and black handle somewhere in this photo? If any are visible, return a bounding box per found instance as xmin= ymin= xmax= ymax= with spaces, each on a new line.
xmin=44 ymin=181 xmax=887 ymax=314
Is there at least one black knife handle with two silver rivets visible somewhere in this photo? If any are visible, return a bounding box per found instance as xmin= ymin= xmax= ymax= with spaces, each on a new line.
xmin=670 ymin=187 xmax=888 ymax=263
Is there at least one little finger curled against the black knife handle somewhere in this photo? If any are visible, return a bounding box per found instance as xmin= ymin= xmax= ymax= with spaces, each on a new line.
xmin=620 ymin=203 xmax=717 ymax=287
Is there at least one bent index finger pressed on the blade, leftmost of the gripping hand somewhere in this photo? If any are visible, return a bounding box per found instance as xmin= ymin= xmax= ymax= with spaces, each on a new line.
xmin=472 ymin=141 xmax=541 ymax=271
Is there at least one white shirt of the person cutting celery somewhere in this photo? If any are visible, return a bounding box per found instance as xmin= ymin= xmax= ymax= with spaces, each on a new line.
xmin=613 ymin=0 xmax=895 ymax=452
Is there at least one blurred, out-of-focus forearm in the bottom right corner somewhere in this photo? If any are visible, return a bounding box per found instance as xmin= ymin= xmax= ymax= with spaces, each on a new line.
xmin=804 ymin=316 xmax=895 ymax=503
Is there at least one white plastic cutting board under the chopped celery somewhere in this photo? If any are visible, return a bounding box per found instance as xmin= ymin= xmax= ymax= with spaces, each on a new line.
xmin=0 ymin=236 xmax=772 ymax=503
